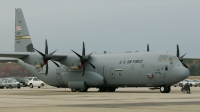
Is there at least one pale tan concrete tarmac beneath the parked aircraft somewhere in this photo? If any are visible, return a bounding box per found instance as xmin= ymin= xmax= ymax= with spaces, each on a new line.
xmin=0 ymin=87 xmax=200 ymax=112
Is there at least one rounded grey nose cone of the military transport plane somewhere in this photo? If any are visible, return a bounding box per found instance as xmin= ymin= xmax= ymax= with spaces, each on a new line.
xmin=175 ymin=66 xmax=190 ymax=81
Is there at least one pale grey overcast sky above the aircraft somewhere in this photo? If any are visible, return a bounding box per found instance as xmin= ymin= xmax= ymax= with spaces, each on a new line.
xmin=0 ymin=0 xmax=200 ymax=58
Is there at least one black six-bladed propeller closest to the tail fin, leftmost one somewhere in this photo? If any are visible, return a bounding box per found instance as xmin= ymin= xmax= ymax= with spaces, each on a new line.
xmin=34 ymin=40 xmax=59 ymax=75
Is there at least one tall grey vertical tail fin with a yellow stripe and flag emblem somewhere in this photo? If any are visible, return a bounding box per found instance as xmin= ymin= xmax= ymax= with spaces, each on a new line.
xmin=15 ymin=8 xmax=35 ymax=52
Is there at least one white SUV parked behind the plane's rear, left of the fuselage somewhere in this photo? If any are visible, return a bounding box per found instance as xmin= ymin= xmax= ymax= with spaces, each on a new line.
xmin=28 ymin=77 xmax=44 ymax=88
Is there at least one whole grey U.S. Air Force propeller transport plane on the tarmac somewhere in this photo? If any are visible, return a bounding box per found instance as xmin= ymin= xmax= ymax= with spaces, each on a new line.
xmin=0 ymin=8 xmax=190 ymax=93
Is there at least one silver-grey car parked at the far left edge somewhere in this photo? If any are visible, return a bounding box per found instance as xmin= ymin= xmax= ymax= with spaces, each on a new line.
xmin=1 ymin=78 xmax=22 ymax=89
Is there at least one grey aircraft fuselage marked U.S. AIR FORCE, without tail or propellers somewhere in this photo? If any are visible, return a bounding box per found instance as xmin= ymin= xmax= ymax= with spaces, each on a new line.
xmin=19 ymin=52 xmax=189 ymax=87
